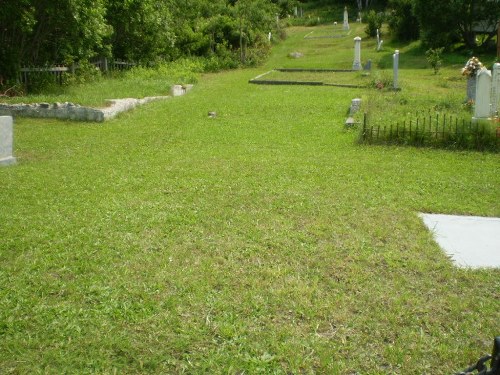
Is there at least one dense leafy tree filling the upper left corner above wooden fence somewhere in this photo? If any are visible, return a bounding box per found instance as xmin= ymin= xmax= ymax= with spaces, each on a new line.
xmin=0 ymin=0 xmax=109 ymax=80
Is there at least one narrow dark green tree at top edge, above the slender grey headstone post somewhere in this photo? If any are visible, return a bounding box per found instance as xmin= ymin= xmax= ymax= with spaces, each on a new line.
xmin=388 ymin=0 xmax=420 ymax=41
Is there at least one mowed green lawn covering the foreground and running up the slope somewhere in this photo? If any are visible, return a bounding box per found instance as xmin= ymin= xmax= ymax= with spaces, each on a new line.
xmin=0 ymin=24 xmax=500 ymax=374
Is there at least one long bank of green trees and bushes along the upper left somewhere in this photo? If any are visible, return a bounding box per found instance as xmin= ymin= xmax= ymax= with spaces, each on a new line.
xmin=0 ymin=0 xmax=286 ymax=87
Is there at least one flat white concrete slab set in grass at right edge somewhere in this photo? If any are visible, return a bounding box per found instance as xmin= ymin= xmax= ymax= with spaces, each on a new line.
xmin=420 ymin=214 xmax=500 ymax=268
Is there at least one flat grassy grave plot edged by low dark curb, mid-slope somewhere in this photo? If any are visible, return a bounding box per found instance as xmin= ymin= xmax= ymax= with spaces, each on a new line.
xmin=250 ymin=68 xmax=370 ymax=88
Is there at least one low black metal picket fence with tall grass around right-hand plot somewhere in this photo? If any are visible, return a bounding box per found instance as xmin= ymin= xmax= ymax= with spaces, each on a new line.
xmin=361 ymin=113 xmax=500 ymax=152
